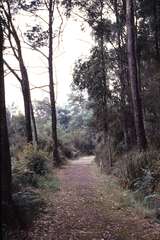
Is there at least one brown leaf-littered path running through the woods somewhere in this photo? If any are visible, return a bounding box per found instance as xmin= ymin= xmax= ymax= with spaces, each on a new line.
xmin=13 ymin=157 xmax=160 ymax=240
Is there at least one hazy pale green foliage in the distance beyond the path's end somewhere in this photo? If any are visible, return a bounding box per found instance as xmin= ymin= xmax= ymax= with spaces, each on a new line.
xmin=32 ymin=94 xmax=94 ymax=159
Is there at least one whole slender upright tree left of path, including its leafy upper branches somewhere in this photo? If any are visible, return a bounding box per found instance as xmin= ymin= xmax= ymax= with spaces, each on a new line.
xmin=21 ymin=0 xmax=62 ymax=165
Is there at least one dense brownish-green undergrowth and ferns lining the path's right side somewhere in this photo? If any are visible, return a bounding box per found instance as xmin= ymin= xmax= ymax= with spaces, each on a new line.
xmin=96 ymin=146 xmax=160 ymax=222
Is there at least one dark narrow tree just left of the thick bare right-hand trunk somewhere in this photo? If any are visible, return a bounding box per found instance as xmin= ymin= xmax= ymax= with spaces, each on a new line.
xmin=112 ymin=0 xmax=131 ymax=149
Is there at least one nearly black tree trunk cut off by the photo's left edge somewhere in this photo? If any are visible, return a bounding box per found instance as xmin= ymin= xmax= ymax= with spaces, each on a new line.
xmin=0 ymin=18 xmax=11 ymax=217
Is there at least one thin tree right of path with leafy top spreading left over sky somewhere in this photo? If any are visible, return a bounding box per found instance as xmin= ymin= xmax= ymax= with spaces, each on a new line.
xmin=62 ymin=0 xmax=111 ymax=139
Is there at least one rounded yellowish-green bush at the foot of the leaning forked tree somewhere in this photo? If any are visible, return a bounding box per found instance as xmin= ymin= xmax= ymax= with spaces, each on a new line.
xmin=12 ymin=145 xmax=49 ymax=192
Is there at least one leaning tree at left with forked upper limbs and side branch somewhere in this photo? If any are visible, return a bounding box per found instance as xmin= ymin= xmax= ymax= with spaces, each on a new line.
xmin=1 ymin=0 xmax=34 ymax=143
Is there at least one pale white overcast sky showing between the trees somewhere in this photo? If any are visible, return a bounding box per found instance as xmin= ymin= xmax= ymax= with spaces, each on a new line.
xmin=5 ymin=8 xmax=94 ymax=112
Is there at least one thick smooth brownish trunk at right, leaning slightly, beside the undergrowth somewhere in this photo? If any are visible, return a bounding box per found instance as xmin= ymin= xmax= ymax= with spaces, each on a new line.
xmin=126 ymin=0 xmax=147 ymax=150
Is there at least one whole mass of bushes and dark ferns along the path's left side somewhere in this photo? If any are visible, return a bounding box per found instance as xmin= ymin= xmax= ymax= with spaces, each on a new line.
xmin=3 ymin=144 xmax=60 ymax=239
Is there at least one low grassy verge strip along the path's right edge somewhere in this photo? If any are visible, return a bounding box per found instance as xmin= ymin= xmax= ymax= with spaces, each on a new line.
xmin=95 ymin=165 xmax=158 ymax=221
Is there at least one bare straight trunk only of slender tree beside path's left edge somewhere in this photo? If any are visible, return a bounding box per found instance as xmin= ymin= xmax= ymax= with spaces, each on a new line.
xmin=48 ymin=0 xmax=61 ymax=165
